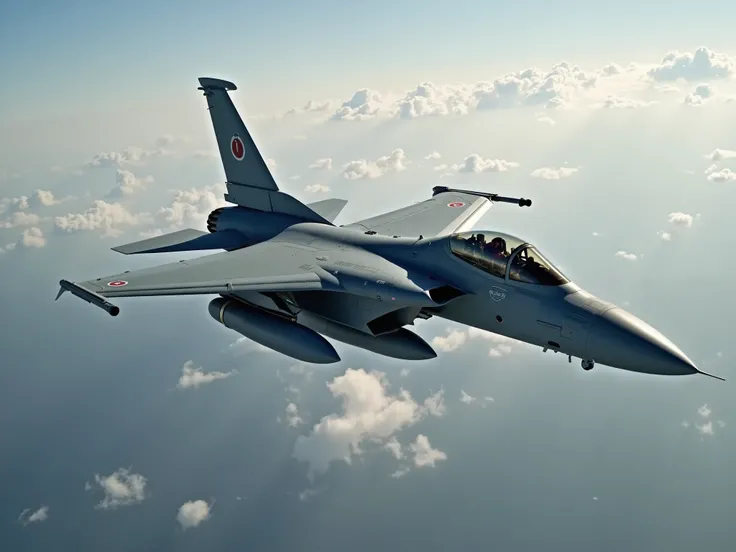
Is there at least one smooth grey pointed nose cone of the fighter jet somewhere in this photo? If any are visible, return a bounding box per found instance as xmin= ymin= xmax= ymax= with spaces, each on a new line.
xmin=588 ymin=307 xmax=698 ymax=376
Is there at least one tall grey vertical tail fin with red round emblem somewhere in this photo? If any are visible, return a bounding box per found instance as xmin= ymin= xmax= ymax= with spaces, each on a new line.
xmin=199 ymin=77 xmax=331 ymax=224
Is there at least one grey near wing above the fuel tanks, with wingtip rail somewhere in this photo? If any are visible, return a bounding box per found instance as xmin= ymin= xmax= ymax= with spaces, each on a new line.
xmin=57 ymin=238 xmax=334 ymax=316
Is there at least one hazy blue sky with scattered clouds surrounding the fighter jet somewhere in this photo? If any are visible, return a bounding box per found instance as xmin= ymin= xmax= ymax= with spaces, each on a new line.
xmin=0 ymin=0 xmax=736 ymax=552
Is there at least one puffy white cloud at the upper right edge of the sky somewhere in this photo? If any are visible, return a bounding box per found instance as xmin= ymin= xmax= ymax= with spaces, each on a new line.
xmin=647 ymin=47 xmax=735 ymax=81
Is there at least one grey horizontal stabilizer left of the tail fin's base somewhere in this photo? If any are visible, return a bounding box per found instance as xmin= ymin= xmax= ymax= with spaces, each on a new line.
xmin=112 ymin=228 xmax=250 ymax=255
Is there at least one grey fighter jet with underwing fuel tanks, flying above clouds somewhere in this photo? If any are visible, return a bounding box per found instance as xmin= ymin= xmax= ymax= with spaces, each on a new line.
xmin=57 ymin=77 xmax=722 ymax=379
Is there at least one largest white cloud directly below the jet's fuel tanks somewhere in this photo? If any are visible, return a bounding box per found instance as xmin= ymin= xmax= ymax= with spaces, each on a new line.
xmin=294 ymin=369 xmax=444 ymax=478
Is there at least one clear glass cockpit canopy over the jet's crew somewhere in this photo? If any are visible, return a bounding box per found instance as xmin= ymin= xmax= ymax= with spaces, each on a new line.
xmin=450 ymin=230 xmax=570 ymax=286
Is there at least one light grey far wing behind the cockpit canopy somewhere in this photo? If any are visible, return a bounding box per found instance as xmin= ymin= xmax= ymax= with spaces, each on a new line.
xmin=346 ymin=189 xmax=491 ymax=238
